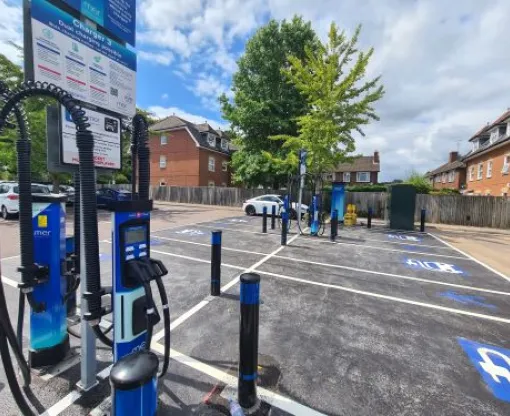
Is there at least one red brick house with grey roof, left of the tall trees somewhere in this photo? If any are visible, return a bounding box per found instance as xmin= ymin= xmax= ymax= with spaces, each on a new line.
xmin=149 ymin=116 xmax=232 ymax=186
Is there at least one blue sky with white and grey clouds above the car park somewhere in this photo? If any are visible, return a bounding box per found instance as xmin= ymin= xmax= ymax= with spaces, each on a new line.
xmin=0 ymin=0 xmax=510 ymax=181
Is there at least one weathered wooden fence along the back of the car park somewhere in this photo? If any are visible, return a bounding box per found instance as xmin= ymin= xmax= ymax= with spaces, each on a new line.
xmin=99 ymin=185 xmax=510 ymax=228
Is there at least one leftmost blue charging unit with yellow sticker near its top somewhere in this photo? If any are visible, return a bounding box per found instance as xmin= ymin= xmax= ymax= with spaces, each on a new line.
xmin=29 ymin=194 xmax=69 ymax=368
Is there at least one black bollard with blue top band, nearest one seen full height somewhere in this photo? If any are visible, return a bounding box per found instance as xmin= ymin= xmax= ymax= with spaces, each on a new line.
xmin=237 ymin=273 xmax=260 ymax=410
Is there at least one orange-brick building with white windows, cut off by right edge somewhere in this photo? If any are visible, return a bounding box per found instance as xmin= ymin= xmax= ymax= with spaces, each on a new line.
xmin=463 ymin=110 xmax=510 ymax=196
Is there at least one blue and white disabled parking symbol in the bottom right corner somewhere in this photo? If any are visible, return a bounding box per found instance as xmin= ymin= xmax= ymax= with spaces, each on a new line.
xmin=458 ymin=338 xmax=510 ymax=402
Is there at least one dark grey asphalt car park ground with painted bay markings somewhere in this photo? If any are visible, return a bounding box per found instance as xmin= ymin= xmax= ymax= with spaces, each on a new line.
xmin=0 ymin=215 xmax=510 ymax=416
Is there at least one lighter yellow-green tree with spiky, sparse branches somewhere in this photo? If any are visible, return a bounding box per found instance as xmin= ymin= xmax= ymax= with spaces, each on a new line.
xmin=266 ymin=23 xmax=384 ymax=174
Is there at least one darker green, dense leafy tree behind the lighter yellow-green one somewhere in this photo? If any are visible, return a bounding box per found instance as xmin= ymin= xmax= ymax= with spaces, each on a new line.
xmin=220 ymin=17 xmax=318 ymax=186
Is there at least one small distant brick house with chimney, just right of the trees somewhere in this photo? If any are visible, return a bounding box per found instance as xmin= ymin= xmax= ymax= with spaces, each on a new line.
xmin=329 ymin=151 xmax=381 ymax=185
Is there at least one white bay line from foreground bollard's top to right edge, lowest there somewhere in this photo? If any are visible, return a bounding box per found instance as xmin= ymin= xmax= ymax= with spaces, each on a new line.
xmin=254 ymin=270 xmax=510 ymax=324
